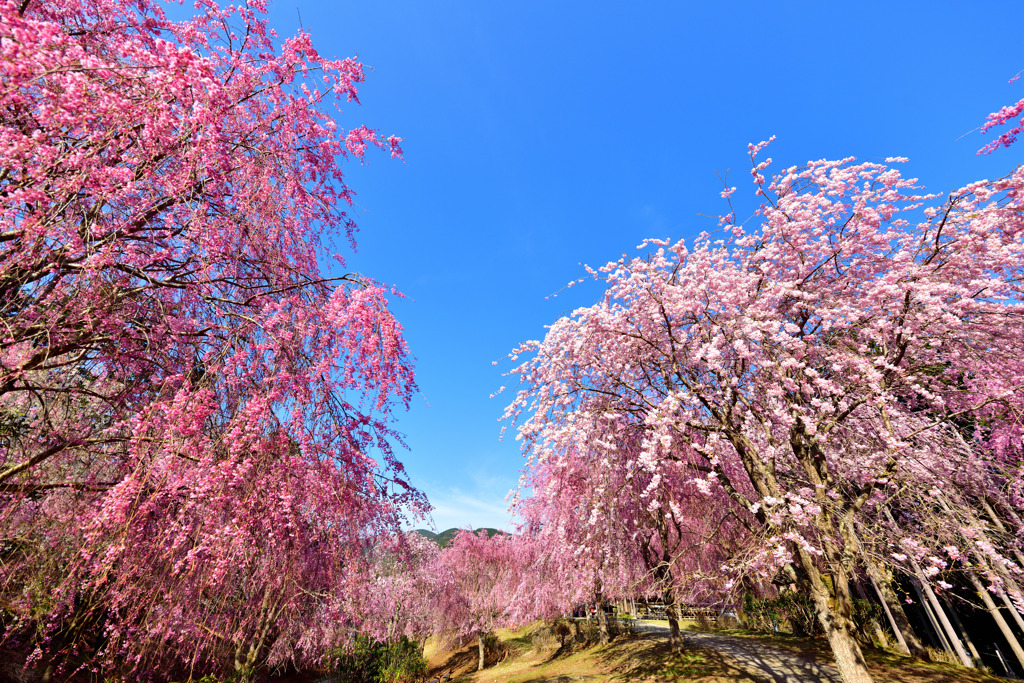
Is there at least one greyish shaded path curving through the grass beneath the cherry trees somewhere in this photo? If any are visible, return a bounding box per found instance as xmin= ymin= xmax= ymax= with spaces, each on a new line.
xmin=636 ymin=623 xmax=842 ymax=683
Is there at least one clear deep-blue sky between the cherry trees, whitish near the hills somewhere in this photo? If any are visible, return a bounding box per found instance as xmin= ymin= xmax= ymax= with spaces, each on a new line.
xmin=251 ymin=0 xmax=1024 ymax=530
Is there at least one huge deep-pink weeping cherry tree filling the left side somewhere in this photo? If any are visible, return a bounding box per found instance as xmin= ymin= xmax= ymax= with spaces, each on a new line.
xmin=0 ymin=0 xmax=425 ymax=677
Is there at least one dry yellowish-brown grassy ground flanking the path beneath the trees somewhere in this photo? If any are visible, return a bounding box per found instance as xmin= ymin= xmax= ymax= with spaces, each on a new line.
xmin=426 ymin=625 xmax=1006 ymax=683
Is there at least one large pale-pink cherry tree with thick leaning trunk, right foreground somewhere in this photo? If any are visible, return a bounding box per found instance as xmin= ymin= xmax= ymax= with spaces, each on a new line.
xmin=508 ymin=136 xmax=1024 ymax=683
